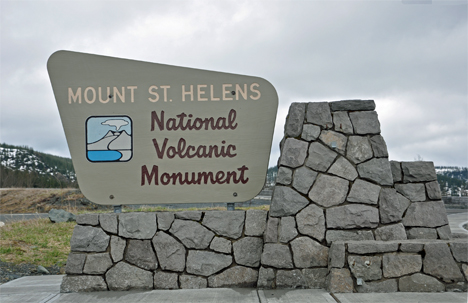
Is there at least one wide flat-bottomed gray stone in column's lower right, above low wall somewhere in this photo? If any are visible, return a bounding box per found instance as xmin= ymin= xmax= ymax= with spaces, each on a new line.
xmin=325 ymin=204 xmax=379 ymax=229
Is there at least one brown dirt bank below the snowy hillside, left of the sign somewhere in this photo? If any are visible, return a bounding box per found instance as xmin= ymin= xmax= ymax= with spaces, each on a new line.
xmin=0 ymin=188 xmax=112 ymax=214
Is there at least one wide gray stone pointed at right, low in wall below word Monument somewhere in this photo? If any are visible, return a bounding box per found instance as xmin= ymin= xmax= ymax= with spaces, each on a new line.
xmin=187 ymin=250 xmax=232 ymax=277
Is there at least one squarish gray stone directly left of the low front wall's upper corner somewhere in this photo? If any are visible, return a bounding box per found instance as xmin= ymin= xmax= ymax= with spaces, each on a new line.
xmin=291 ymin=237 xmax=328 ymax=268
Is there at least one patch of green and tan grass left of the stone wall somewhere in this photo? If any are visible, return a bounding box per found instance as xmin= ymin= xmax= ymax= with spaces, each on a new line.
xmin=0 ymin=219 xmax=76 ymax=266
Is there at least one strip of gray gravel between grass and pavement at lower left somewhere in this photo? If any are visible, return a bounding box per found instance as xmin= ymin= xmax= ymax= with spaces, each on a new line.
xmin=0 ymin=260 xmax=63 ymax=284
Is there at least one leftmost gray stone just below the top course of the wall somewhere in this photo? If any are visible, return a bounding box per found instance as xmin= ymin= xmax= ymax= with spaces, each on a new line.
xmin=70 ymin=225 xmax=110 ymax=252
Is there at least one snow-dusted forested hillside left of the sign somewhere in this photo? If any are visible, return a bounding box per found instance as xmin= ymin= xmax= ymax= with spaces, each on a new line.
xmin=0 ymin=143 xmax=78 ymax=188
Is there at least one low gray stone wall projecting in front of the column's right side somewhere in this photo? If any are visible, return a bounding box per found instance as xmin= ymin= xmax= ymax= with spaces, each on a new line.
xmin=327 ymin=239 xmax=468 ymax=292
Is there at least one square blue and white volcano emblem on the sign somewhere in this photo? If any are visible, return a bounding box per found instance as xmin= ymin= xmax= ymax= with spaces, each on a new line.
xmin=86 ymin=116 xmax=133 ymax=162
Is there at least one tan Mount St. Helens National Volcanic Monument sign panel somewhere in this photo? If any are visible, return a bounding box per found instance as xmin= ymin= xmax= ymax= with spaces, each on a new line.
xmin=48 ymin=51 xmax=278 ymax=205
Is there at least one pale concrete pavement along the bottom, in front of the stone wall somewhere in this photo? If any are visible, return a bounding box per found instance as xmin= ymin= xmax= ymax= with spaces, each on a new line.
xmin=0 ymin=276 xmax=467 ymax=303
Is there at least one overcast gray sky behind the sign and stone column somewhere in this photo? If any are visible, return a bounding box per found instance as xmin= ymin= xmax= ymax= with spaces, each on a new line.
xmin=0 ymin=0 xmax=468 ymax=166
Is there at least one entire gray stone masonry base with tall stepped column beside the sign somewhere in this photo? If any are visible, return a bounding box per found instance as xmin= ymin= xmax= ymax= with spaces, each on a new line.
xmin=61 ymin=100 xmax=468 ymax=292
